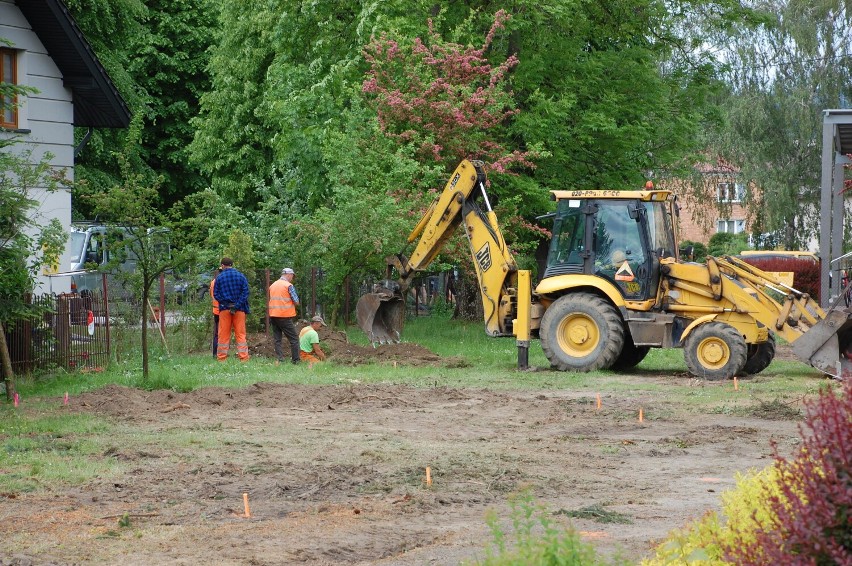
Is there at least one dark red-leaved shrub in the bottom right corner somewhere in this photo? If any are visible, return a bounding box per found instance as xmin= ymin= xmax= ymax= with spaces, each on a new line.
xmin=725 ymin=382 xmax=852 ymax=566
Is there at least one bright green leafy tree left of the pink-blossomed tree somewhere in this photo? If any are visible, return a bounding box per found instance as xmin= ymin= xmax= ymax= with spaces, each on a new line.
xmin=191 ymin=0 xmax=433 ymax=210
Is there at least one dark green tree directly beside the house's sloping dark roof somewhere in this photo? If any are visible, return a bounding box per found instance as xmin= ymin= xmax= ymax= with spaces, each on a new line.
xmin=68 ymin=0 xmax=217 ymax=217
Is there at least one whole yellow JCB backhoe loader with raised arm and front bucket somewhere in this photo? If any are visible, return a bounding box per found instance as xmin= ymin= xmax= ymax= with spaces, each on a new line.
xmin=357 ymin=161 xmax=852 ymax=379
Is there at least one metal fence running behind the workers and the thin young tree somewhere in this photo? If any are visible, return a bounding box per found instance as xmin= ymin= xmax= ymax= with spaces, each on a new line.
xmin=6 ymin=268 xmax=464 ymax=374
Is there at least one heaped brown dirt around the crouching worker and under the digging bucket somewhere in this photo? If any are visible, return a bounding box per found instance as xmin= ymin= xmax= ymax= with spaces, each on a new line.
xmin=243 ymin=322 xmax=466 ymax=367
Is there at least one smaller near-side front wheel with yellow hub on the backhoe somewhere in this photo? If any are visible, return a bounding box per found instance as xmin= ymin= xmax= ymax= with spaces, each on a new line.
xmin=683 ymin=322 xmax=748 ymax=381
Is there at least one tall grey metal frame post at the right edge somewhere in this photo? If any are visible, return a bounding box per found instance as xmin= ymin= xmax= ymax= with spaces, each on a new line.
xmin=819 ymin=108 xmax=852 ymax=307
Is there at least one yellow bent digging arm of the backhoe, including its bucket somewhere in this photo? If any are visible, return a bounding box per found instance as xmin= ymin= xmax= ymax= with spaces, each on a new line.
xmin=356 ymin=160 xmax=518 ymax=343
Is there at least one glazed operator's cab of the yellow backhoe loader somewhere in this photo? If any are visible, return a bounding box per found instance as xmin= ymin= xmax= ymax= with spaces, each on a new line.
xmin=544 ymin=190 xmax=677 ymax=301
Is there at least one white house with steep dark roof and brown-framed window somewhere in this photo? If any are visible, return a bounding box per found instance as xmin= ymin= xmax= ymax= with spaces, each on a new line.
xmin=0 ymin=0 xmax=130 ymax=293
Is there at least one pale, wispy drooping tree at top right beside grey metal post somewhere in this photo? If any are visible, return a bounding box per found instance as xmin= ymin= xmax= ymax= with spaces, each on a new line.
xmin=708 ymin=0 xmax=852 ymax=249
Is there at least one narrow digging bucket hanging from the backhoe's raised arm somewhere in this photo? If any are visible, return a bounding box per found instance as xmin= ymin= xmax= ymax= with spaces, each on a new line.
xmin=355 ymin=281 xmax=405 ymax=344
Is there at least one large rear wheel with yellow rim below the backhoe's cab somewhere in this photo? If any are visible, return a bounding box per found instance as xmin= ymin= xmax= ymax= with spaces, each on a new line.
xmin=539 ymin=293 xmax=624 ymax=371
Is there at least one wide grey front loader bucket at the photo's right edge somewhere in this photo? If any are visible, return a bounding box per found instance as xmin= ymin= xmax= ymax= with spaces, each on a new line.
xmin=792 ymin=309 xmax=852 ymax=379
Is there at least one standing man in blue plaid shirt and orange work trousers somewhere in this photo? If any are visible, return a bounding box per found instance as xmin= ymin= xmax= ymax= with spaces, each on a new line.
xmin=213 ymin=257 xmax=249 ymax=362
